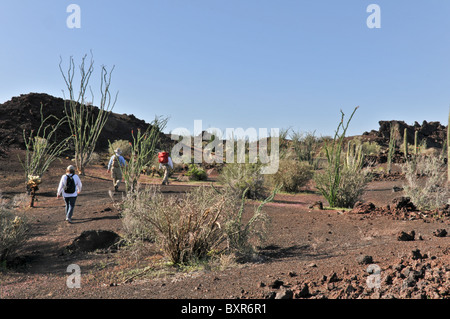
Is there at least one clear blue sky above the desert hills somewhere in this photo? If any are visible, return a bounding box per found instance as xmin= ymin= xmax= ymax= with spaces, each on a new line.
xmin=0 ymin=0 xmax=450 ymax=136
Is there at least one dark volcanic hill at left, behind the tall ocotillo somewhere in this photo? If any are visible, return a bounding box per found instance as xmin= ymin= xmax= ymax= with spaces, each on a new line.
xmin=0 ymin=93 xmax=170 ymax=151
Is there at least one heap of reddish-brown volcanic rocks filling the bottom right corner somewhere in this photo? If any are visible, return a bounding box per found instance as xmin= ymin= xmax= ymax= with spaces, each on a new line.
xmin=265 ymin=249 xmax=450 ymax=299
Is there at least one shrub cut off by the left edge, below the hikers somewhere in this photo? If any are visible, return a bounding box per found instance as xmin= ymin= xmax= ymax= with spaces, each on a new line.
xmin=0 ymin=198 xmax=28 ymax=262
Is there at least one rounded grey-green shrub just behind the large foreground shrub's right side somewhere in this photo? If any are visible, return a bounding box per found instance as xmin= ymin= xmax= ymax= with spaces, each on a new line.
xmin=219 ymin=163 xmax=267 ymax=199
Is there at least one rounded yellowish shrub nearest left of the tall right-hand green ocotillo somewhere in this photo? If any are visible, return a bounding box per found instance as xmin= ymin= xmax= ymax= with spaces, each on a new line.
xmin=267 ymin=159 xmax=314 ymax=193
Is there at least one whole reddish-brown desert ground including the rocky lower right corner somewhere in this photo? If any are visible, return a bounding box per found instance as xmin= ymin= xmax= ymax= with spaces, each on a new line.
xmin=0 ymin=148 xmax=450 ymax=299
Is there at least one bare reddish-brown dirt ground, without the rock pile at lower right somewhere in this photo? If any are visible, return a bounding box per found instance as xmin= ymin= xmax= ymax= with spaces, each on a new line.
xmin=0 ymin=154 xmax=450 ymax=299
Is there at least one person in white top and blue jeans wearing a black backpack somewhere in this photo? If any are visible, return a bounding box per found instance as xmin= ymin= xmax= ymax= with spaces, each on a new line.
xmin=56 ymin=165 xmax=82 ymax=223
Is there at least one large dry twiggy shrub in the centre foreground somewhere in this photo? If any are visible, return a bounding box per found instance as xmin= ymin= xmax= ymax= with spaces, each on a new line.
xmin=122 ymin=186 xmax=273 ymax=264
